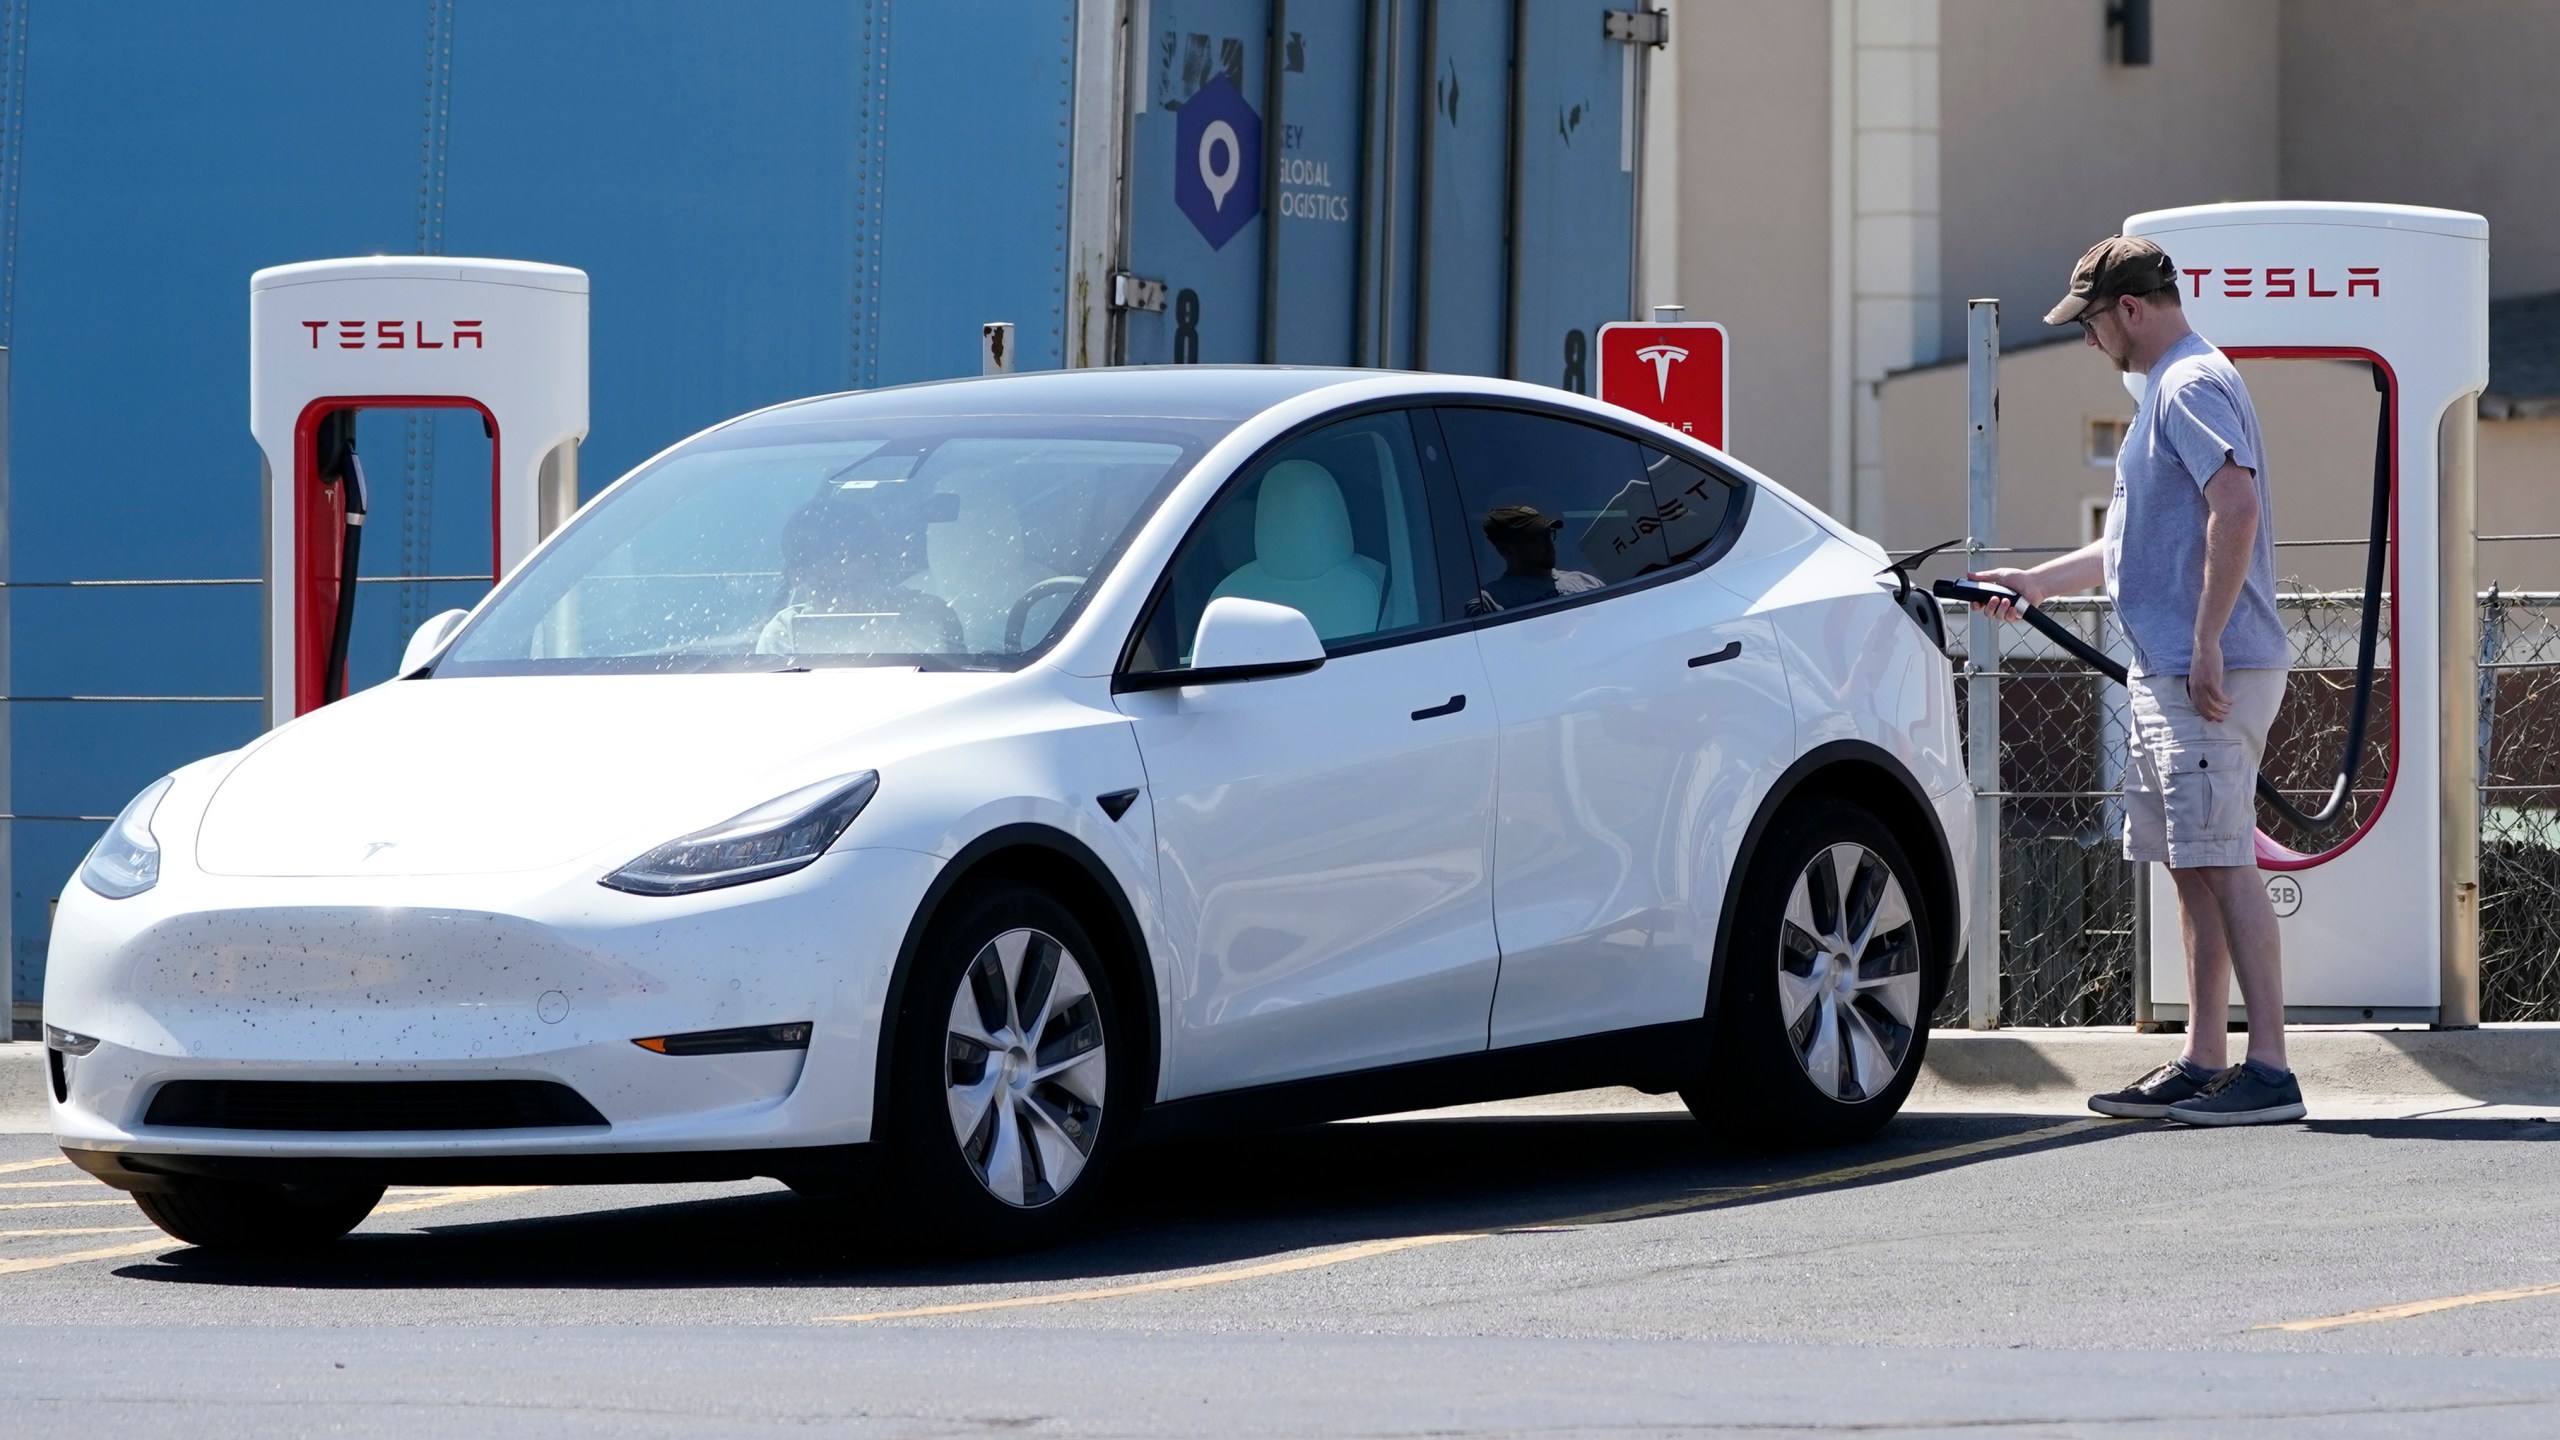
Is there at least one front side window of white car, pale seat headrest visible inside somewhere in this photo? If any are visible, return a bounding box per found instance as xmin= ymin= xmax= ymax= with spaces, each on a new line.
xmin=1129 ymin=410 xmax=1444 ymax=671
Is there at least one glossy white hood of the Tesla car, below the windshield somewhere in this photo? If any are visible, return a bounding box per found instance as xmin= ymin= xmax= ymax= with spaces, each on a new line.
xmin=195 ymin=669 xmax=1006 ymax=876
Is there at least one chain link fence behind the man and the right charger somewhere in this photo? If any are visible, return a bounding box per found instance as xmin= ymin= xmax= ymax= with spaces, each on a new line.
xmin=1935 ymin=576 xmax=2560 ymax=1025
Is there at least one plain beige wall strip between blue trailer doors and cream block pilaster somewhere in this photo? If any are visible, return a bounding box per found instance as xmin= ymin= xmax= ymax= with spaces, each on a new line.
xmin=1661 ymin=0 xmax=1830 ymax=491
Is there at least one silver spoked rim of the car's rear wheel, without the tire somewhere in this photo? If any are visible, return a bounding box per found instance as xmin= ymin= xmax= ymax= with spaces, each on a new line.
xmin=1777 ymin=843 xmax=1920 ymax=1104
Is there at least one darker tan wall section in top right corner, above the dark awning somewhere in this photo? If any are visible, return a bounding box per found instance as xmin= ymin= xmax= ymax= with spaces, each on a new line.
xmin=2293 ymin=0 xmax=2560 ymax=295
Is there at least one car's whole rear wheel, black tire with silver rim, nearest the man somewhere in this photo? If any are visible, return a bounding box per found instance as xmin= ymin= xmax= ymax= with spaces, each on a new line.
xmin=1679 ymin=797 xmax=1946 ymax=1148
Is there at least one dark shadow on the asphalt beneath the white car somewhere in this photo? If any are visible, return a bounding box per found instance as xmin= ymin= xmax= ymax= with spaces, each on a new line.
xmin=115 ymin=1115 xmax=2148 ymax=1304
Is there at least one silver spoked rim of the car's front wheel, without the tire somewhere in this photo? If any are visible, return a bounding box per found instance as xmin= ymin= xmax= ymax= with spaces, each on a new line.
xmin=942 ymin=930 xmax=1108 ymax=1209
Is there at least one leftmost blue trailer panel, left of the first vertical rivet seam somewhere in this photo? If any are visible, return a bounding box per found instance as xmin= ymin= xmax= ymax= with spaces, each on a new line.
xmin=10 ymin=0 xmax=425 ymax=999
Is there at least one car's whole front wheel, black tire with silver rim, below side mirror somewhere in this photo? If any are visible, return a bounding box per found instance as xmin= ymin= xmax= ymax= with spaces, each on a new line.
xmin=888 ymin=884 xmax=1139 ymax=1253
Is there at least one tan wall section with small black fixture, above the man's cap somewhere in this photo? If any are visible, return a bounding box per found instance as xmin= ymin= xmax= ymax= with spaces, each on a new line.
xmin=1938 ymin=0 xmax=2283 ymax=354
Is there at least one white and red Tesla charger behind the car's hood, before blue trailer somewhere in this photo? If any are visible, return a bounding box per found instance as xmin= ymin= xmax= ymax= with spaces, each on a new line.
xmin=248 ymin=256 xmax=586 ymax=728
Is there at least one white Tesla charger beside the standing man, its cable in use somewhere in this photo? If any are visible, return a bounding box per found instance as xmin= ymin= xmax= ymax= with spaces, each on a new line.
xmin=2125 ymin=202 xmax=2488 ymax=1025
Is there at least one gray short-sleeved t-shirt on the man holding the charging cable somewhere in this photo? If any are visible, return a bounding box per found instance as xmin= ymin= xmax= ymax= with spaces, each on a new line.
xmin=2107 ymin=336 xmax=2291 ymax=674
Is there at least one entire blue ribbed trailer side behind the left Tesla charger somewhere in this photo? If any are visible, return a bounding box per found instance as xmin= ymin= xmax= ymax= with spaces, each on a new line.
xmin=10 ymin=0 xmax=1075 ymax=999
